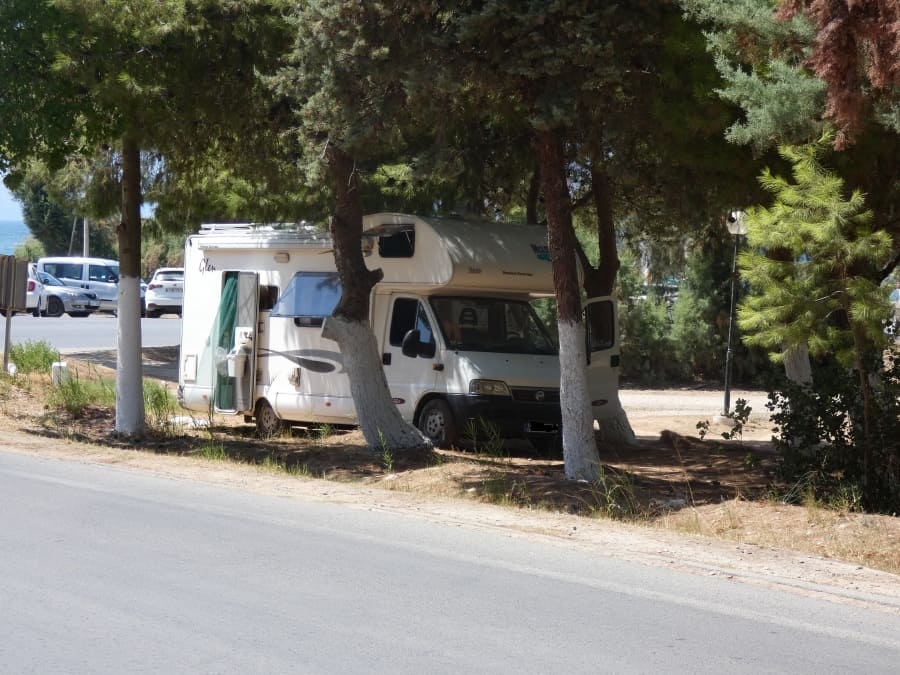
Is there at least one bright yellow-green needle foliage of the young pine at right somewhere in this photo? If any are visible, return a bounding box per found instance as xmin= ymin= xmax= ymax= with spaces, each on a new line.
xmin=738 ymin=135 xmax=891 ymax=367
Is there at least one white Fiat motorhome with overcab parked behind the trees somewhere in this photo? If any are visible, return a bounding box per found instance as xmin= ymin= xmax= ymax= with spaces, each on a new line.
xmin=178 ymin=213 xmax=619 ymax=445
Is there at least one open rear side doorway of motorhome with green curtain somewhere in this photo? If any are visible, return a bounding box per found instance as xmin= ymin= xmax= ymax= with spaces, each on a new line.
xmin=210 ymin=271 xmax=259 ymax=414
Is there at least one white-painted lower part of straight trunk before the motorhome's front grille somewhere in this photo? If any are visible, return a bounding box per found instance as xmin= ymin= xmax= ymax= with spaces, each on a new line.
xmin=558 ymin=321 xmax=600 ymax=481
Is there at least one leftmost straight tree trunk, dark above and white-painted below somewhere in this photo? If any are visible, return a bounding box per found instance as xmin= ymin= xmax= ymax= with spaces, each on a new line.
xmin=116 ymin=136 xmax=144 ymax=438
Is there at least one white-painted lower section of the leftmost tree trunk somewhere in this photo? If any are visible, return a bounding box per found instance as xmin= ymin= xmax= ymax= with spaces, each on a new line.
xmin=116 ymin=277 xmax=144 ymax=437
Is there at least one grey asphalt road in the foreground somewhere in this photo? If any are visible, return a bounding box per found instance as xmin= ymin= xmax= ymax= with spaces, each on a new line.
xmin=0 ymin=451 xmax=900 ymax=674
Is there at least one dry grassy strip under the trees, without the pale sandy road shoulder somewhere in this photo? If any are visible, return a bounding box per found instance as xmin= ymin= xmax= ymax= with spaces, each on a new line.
xmin=0 ymin=360 xmax=900 ymax=574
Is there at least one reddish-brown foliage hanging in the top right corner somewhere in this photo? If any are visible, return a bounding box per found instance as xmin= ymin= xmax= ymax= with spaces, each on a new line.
xmin=779 ymin=0 xmax=900 ymax=149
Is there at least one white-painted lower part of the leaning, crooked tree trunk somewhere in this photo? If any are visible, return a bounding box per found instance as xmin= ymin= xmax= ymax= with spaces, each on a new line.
xmin=322 ymin=316 xmax=432 ymax=452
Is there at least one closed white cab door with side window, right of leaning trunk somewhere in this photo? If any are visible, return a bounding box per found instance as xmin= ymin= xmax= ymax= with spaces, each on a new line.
xmin=375 ymin=294 xmax=437 ymax=420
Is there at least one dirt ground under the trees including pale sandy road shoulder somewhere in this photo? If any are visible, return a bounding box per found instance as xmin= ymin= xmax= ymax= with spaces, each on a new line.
xmin=0 ymin=350 xmax=900 ymax=614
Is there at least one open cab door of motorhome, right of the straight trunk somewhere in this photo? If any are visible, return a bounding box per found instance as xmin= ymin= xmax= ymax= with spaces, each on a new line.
xmin=584 ymin=296 xmax=619 ymax=420
